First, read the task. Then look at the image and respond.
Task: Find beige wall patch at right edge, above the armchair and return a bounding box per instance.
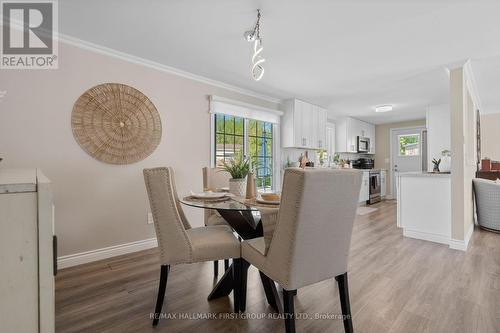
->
[481,113,500,161]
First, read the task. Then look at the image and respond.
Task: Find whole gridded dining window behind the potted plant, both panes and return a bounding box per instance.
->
[214,114,274,191]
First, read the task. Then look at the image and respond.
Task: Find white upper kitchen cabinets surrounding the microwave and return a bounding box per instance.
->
[336,117,375,154]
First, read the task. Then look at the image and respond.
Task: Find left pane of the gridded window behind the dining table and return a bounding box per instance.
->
[215,114,245,167]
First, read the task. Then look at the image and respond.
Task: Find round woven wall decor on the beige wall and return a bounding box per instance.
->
[71,83,161,164]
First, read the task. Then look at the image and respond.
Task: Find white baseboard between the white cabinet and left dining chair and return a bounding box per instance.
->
[57,238,158,269]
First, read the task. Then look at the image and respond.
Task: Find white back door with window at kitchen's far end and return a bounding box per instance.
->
[389,126,427,199]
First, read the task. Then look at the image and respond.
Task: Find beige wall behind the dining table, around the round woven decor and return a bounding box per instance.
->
[0,43,277,255]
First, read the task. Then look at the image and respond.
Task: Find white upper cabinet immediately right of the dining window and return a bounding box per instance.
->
[281,99,327,149]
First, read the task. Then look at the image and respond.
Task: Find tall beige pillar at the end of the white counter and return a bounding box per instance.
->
[450,68,476,241]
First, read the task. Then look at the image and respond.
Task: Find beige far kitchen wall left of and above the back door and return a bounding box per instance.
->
[375,119,425,195]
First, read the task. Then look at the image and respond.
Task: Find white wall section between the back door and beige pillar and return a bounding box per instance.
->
[426,104,451,171]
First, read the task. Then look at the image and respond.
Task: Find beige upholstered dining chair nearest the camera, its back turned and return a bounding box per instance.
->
[240,168,362,332]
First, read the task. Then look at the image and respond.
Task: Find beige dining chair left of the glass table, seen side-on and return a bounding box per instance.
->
[143,168,240,326]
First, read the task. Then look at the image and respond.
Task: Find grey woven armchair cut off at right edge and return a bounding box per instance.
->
[473,178,500,232]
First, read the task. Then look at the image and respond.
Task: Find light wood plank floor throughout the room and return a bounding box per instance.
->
[56,202,500,333]
